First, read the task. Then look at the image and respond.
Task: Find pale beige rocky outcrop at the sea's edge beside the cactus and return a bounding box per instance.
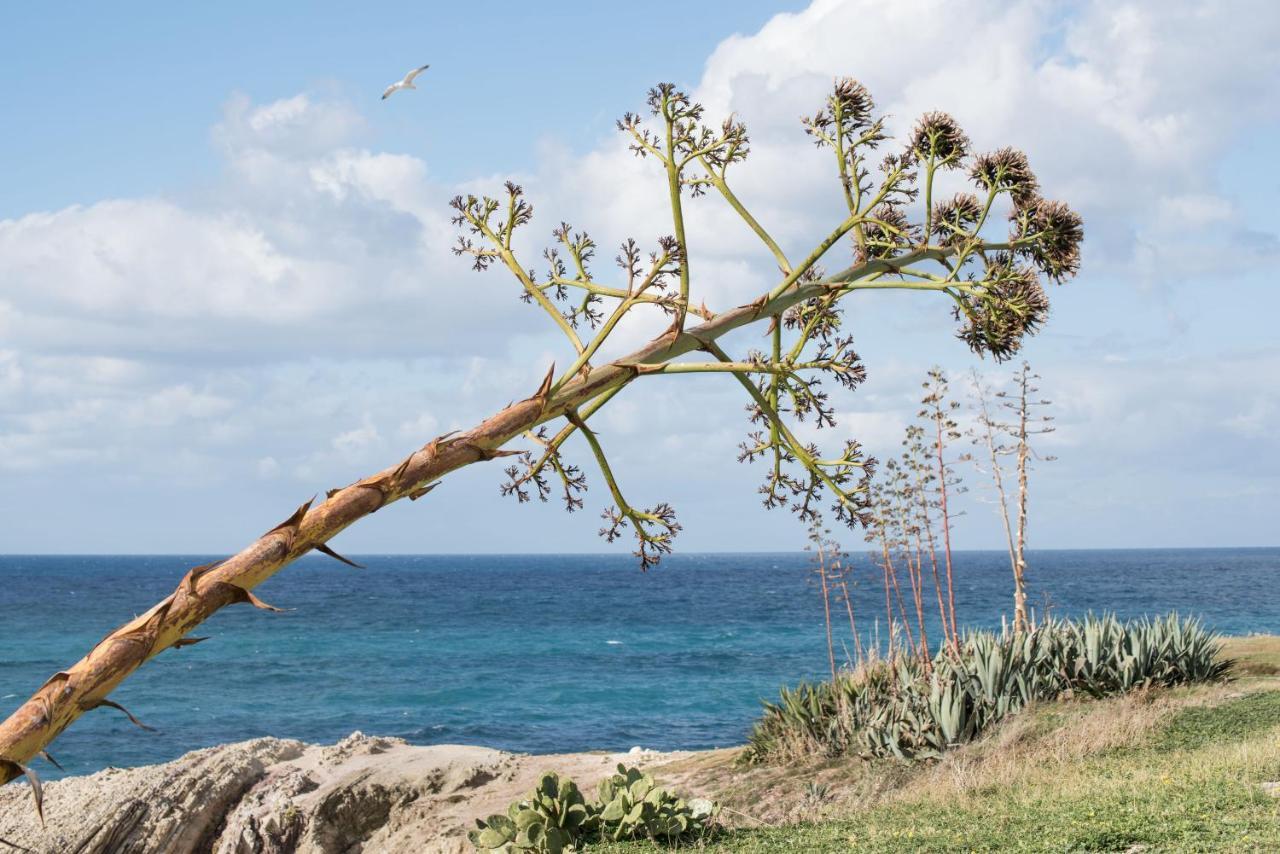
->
[0,732,682,854]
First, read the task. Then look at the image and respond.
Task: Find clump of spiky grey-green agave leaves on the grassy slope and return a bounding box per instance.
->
[742,613,1231,762]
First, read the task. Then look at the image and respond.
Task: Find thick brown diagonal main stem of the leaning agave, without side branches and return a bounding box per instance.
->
[0,247,950,784]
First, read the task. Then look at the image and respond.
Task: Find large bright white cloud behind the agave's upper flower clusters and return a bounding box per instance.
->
[537,0,1280,297]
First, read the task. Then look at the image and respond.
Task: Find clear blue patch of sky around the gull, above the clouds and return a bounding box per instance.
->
[0,0,804,216]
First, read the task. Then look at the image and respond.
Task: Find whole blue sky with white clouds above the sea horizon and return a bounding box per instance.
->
[0,0,1280,553]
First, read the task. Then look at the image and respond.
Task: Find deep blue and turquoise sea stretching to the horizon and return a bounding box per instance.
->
[0,548,1280,776]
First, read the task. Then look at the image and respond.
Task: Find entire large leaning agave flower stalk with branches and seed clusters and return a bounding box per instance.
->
[0,79,1082,814]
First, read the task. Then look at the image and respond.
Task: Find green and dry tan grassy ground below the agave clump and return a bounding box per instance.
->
[591,638,1280,854]
